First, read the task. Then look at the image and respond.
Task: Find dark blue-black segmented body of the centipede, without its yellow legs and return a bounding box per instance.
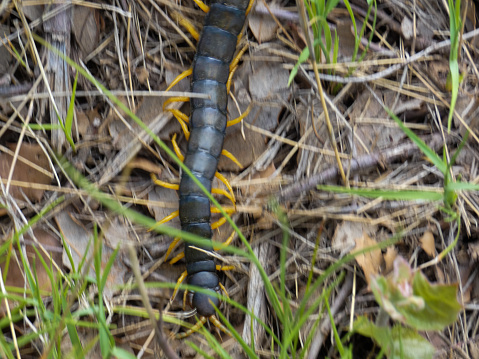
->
[179,0,250,317]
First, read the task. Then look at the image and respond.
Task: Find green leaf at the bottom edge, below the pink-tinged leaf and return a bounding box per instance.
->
[353,317,434,359]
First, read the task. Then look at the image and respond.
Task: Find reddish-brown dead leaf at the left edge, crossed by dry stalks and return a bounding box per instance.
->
[0,143,53,207]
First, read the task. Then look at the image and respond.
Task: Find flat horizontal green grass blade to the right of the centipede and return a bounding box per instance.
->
[317,185,444,201]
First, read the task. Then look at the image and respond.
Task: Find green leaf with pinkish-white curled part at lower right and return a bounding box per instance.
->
[371,257,462,330]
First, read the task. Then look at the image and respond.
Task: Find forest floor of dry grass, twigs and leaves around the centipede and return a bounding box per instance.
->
[0,0,479,358]
